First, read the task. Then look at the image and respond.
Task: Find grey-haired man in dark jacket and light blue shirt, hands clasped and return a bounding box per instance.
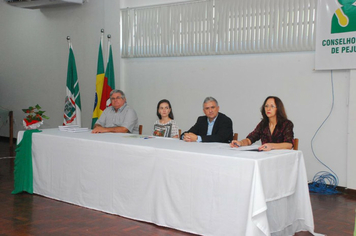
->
[180,97,233,143]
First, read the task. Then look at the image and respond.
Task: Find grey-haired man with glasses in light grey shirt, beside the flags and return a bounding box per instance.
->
[92,89,138,134]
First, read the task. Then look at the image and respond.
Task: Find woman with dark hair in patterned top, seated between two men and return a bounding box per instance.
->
[153,99,178,138]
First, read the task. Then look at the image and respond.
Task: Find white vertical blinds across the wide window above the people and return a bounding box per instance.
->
[121,0,316,57]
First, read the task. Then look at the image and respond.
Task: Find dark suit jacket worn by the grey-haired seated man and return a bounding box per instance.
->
[181,112,233,143]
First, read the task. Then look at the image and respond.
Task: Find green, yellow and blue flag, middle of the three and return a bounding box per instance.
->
[91,34,105,128]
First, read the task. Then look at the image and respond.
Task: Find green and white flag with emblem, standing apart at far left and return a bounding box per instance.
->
[63,43,81,127]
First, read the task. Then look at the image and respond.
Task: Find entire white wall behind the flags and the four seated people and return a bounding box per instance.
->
[0,0,355,186]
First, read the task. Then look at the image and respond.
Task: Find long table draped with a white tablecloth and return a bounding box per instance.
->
[19,129,314,236]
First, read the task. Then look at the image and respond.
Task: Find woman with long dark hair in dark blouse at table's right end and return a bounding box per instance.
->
[230,96,294,151]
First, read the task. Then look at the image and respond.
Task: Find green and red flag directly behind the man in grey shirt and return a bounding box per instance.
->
[100,40,115,111]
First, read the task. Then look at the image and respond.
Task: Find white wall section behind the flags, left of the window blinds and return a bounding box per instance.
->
[0,0,120,135]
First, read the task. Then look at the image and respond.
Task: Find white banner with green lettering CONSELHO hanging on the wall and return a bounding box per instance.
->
[315,0,356,70]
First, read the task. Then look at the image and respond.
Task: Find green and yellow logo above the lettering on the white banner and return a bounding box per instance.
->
[331,0,356,34]
